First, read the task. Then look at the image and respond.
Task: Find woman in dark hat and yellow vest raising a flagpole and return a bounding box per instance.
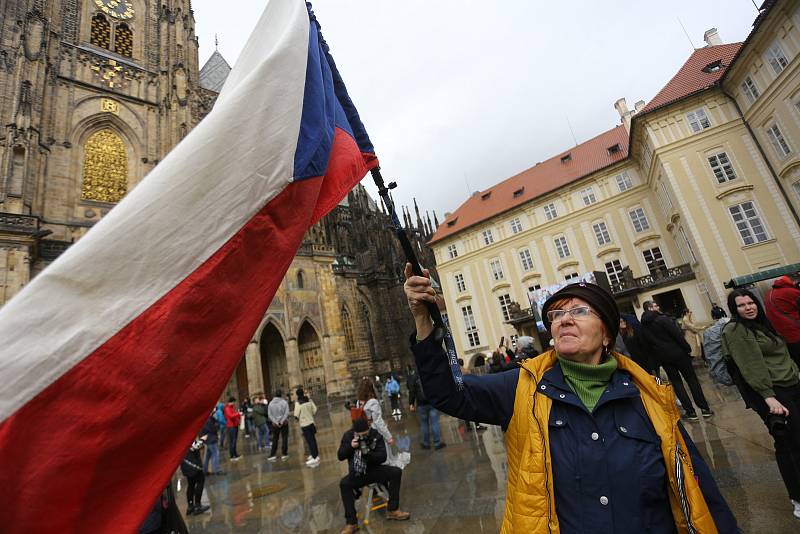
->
[405,265,738,534]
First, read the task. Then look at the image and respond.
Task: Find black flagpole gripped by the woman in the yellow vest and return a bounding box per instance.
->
[370,167,464,390]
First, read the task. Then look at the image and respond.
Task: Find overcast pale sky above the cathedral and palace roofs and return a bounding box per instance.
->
[192,0,760,222]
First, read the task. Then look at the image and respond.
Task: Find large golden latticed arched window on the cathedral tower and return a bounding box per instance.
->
[81,129,128,202]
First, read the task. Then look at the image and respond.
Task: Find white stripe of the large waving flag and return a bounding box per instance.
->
[0,0,308,421]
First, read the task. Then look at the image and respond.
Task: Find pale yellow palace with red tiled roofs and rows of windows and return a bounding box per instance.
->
[429,0,800,363]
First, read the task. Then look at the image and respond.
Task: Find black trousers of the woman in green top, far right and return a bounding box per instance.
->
[756,386,800,502]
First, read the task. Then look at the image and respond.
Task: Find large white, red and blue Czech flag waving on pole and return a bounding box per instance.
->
[0,0,377,534]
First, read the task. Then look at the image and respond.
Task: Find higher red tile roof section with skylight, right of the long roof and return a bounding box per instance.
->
[642,43,742,113]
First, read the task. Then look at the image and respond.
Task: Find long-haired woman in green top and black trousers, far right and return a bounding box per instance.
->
[722,289,800,518]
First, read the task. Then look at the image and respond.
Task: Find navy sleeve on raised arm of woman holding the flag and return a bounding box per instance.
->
[411,335,520,430]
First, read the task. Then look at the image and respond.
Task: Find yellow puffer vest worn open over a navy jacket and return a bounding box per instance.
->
[501,351,717,534]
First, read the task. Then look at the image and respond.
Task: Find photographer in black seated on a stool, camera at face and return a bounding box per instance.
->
[338,418,411,534]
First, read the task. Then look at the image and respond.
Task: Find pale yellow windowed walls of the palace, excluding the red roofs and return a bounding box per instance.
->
[433,2,800,363]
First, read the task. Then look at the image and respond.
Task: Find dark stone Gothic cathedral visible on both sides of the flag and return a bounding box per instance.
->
[0,0,435,397]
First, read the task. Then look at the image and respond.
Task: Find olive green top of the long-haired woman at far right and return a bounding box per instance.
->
[722,322,800,399]
